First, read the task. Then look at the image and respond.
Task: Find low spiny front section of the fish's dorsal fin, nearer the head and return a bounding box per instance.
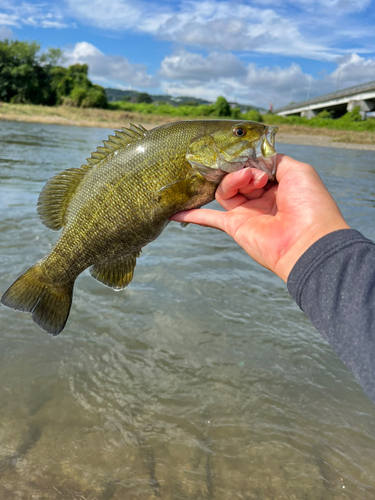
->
[82,123,147,169]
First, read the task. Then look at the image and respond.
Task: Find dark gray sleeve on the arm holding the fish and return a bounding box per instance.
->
[288,229,375,402]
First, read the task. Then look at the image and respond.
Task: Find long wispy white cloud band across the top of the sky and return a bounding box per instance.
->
[64,0,337,60]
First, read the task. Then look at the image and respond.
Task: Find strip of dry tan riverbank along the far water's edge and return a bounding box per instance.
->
[0,103,375,151]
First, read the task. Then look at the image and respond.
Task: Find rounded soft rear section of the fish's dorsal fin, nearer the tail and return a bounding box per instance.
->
[37,168,86,231]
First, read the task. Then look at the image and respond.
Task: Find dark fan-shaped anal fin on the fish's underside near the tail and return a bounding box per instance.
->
[90,252,140,290]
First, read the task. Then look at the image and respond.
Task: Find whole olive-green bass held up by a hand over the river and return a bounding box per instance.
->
[1,120,277,336]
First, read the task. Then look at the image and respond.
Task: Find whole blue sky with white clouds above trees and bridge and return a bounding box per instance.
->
[0,0,375,109]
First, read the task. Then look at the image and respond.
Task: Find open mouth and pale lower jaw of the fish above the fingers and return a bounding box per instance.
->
[218,127,278,181]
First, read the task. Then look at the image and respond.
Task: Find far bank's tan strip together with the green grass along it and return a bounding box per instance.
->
[0,103,375,145]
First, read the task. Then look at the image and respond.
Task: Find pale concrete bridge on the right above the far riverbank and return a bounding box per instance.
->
[274,81,375,119]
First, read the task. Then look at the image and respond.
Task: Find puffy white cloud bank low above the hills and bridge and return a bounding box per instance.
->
[162,48,375,108]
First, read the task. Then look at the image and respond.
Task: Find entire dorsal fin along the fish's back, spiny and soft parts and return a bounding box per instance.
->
[37,123,147,231]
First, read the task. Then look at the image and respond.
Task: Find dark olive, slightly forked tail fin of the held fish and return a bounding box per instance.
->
[1,264,74,335]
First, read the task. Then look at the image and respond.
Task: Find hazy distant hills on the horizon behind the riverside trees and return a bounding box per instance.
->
[105,88,266,113]
